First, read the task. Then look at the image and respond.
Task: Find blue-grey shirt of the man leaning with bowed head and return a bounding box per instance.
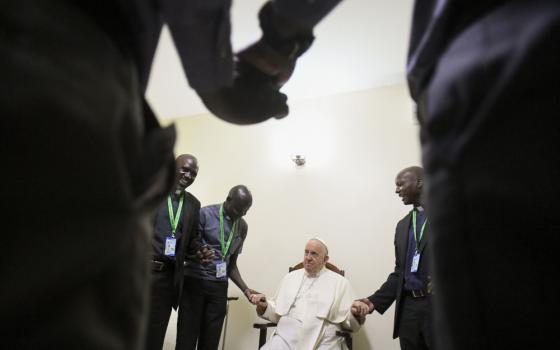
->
[185,204,246,281]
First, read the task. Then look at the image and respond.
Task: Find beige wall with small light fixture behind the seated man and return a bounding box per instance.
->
[160,84,420,350]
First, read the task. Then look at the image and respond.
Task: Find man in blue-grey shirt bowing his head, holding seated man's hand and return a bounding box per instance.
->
[177,185,256,350]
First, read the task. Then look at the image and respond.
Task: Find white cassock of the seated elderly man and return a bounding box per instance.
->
[260,268,360,350]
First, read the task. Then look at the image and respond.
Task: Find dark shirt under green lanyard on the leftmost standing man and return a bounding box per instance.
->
[152,197,185,260]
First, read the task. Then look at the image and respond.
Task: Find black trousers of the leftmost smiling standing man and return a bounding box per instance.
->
[144,268,180,350]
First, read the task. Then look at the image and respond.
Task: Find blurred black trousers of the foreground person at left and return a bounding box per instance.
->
[0,0,173,350]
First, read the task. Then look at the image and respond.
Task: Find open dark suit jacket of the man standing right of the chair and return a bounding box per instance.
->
[368,211,431,338]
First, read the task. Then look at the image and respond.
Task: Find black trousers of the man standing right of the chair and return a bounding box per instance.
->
[399,296,434,350]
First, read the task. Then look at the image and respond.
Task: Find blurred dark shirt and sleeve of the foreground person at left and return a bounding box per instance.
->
[75,0,233,94]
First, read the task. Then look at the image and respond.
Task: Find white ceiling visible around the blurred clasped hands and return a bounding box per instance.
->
[146,0,413,119]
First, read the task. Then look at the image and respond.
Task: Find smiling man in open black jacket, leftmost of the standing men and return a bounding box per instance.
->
[145,154,200,350]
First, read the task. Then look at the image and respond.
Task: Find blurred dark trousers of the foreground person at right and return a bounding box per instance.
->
[422,1,560,350]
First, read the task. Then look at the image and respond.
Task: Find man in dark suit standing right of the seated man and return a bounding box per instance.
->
[361,166,434,350]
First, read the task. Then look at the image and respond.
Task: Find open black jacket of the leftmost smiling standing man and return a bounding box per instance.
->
[173,192,202,307]
